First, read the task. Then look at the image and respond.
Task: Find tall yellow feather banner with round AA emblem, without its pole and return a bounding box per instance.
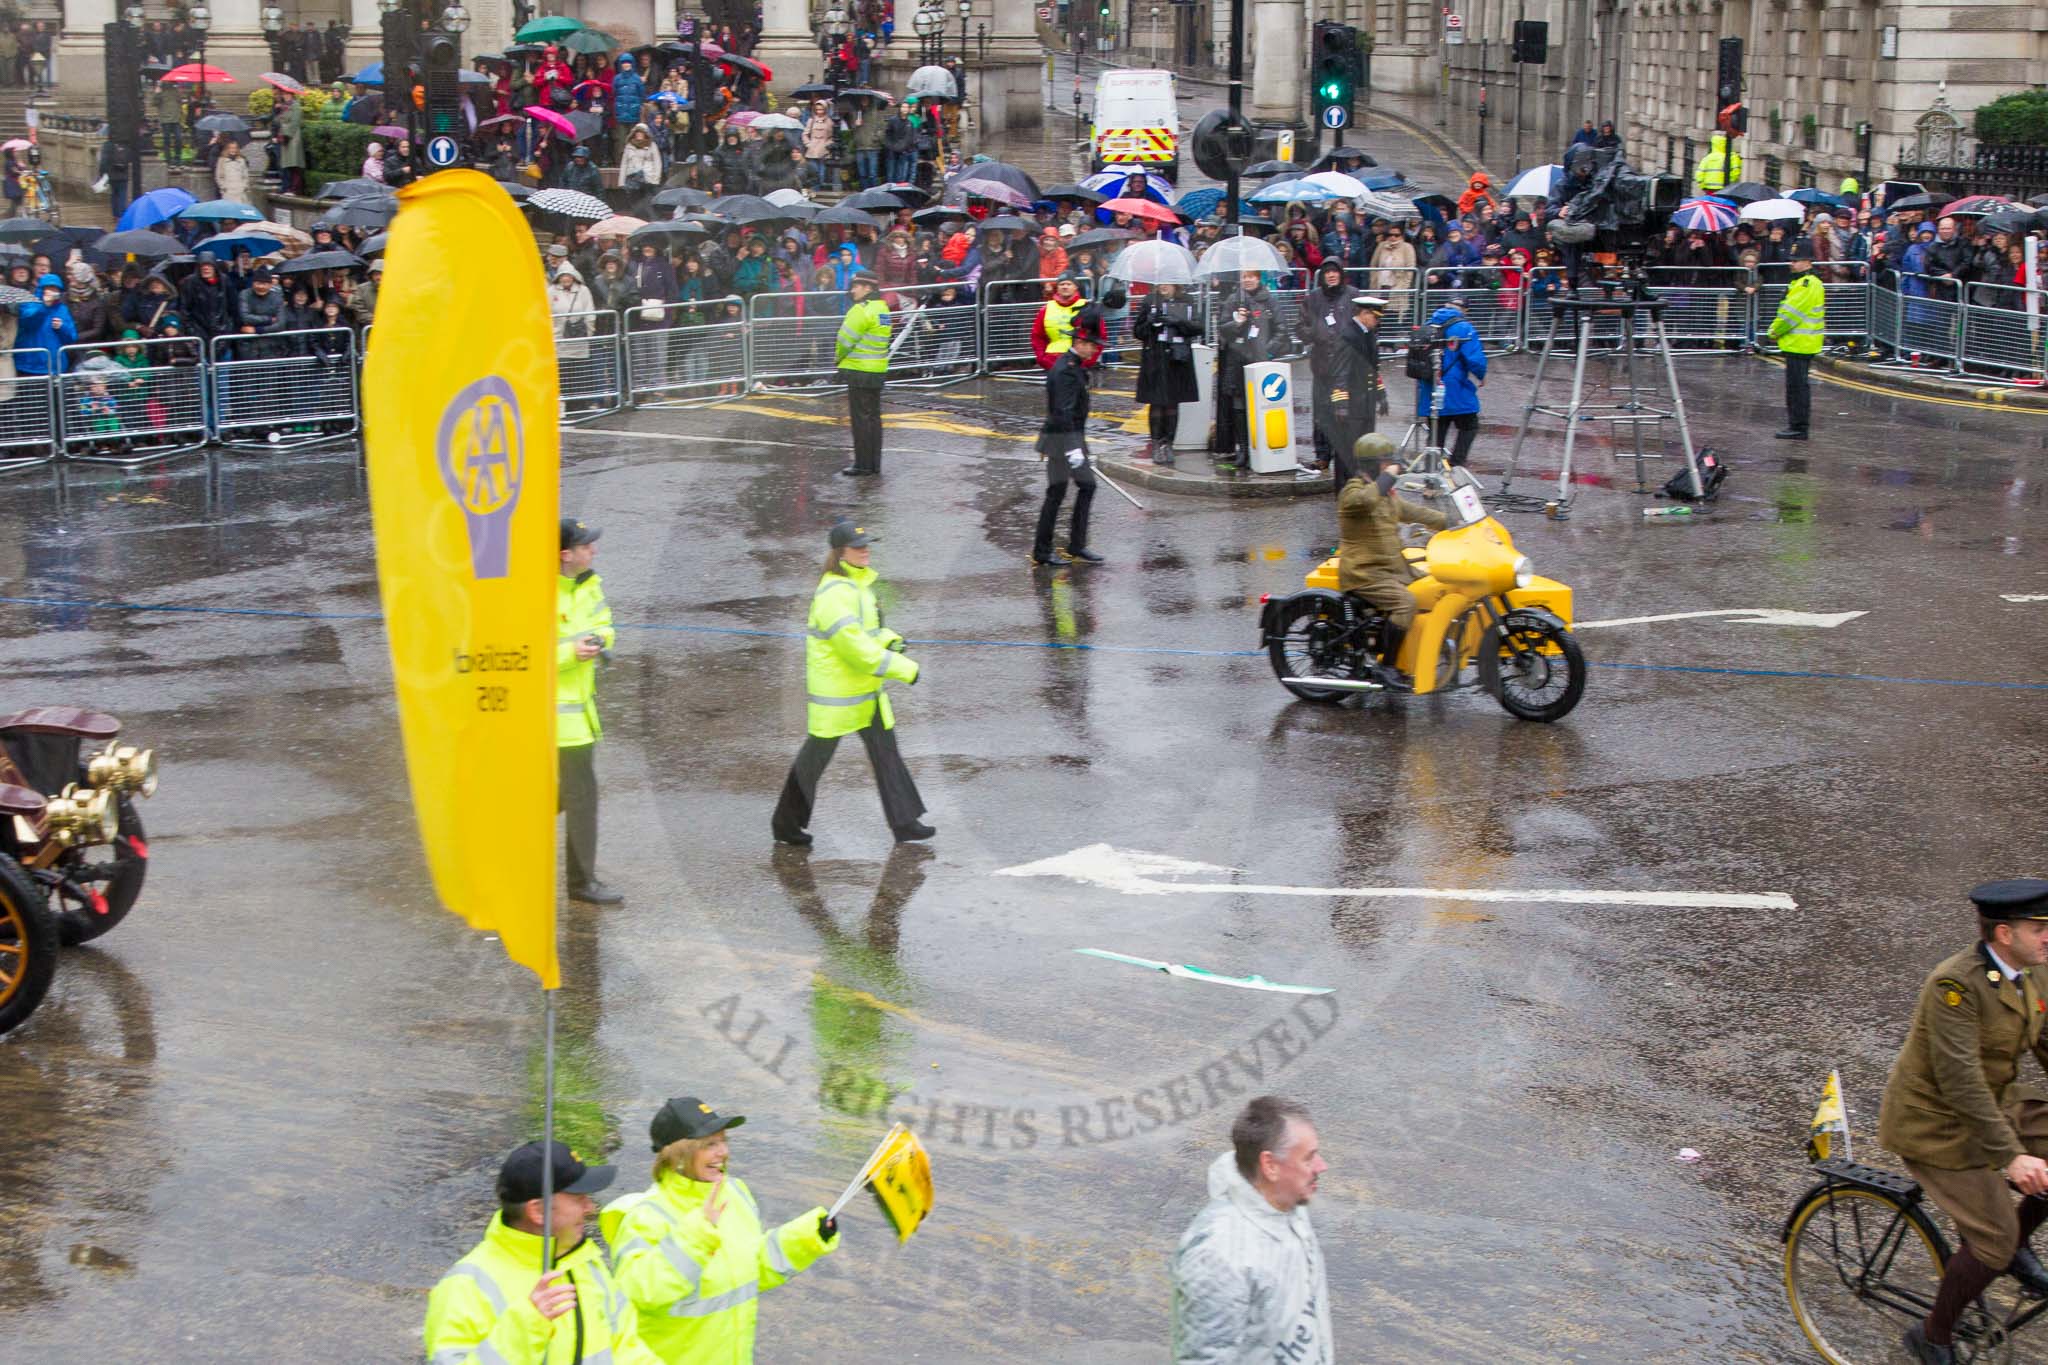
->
[362,170,561,988]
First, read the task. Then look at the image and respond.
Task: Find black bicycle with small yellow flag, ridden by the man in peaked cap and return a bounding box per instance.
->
[1780,1156,2048,1365]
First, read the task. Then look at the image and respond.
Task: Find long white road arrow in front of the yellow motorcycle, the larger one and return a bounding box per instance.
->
[995,843,1798,911]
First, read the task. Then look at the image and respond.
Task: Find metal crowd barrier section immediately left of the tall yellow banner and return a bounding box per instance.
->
[209,327,362,446]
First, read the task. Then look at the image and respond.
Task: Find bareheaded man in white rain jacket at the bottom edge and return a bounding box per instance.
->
[1174,1095,1337,1365]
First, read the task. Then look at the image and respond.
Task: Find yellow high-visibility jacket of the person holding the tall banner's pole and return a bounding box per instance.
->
[426,1214,662,1365]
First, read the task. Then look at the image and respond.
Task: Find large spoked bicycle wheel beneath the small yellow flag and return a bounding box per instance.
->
[1784,1185,1948,1365]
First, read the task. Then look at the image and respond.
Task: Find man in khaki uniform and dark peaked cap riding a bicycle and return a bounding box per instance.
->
[1878,878,2048,1365]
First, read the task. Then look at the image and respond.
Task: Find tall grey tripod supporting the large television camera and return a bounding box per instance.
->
[1501,276,1706,510]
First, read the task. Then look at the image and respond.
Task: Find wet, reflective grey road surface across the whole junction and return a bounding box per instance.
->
[0,333,2048,1363]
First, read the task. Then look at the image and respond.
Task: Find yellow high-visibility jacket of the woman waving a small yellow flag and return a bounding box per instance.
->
[598,1171,840,1365]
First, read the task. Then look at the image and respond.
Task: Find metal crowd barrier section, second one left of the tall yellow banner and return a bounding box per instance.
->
[55,336,213,465]
